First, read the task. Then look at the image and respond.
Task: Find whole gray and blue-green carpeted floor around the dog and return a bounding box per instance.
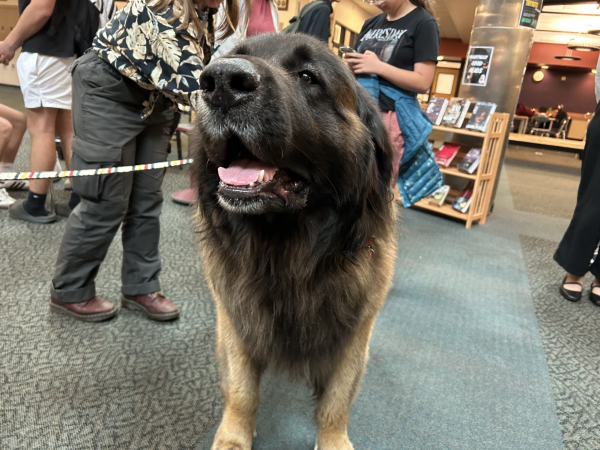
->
[0,83,600,450]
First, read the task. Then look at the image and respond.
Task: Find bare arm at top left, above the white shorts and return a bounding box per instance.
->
[0,0,56,65]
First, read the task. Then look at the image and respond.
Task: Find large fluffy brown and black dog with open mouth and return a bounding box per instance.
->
[193,35,396,450]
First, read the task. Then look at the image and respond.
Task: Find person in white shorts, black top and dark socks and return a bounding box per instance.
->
[0,0,75,223]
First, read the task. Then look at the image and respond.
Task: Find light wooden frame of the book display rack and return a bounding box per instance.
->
[414,113,509,228]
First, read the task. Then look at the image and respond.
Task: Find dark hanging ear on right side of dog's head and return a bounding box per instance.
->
[356,86,393,200]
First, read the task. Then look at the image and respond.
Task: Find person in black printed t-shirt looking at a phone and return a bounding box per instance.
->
[344,0,440,187]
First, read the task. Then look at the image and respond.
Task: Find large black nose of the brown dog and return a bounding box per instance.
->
[200,58,260,113]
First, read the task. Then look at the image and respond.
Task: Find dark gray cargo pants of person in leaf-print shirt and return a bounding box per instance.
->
[51,51,175,303]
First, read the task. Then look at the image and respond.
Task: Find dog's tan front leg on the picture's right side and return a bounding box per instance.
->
[316,318,375,450]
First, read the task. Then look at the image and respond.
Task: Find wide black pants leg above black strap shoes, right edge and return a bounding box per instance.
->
[554,104,600,278]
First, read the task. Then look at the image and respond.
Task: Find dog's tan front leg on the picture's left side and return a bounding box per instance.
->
[211,306,262,450]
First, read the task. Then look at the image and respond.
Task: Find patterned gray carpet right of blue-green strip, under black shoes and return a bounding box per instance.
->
[521,236,600,449]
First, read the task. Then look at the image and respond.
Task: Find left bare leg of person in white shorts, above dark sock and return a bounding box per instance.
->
[27,108,58,194]
